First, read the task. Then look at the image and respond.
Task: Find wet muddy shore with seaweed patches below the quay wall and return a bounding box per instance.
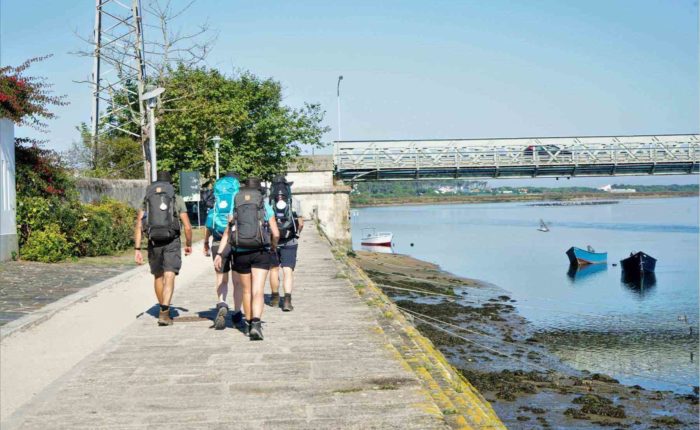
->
[355,251,698,429]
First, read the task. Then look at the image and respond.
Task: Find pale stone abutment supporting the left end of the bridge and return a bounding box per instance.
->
[287,155,351,244]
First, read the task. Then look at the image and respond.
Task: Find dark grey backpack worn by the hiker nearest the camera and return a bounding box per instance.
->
[231,187,270,249]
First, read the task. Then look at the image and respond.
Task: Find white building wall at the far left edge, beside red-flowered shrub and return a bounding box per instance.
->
[0,118,17,261]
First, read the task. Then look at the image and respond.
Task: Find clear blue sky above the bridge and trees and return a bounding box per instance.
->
[0,0,700,185]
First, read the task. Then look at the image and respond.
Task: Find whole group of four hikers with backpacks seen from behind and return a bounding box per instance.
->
[134,171,304,340]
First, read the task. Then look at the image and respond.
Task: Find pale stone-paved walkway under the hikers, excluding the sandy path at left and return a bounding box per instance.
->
[2,228,446,430]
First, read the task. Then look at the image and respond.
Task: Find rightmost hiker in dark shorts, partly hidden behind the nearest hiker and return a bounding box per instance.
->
[270,175,304,312]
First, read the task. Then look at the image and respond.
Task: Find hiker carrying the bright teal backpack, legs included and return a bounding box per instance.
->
[204,172,243,330]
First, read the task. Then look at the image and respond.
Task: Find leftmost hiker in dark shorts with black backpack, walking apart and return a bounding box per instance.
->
[134,171,192,326]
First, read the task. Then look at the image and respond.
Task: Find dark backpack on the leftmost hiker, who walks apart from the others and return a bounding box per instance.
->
[144,182,180,243]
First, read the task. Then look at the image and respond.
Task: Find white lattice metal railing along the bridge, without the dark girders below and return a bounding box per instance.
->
[335,135,700,171]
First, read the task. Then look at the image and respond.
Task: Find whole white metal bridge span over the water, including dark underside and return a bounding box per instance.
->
[334,134,700,181]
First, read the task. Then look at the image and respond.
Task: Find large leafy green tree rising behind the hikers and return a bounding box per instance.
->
[110,64,328,178]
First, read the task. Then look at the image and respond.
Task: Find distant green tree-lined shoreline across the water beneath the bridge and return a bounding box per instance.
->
[350,191,698,208]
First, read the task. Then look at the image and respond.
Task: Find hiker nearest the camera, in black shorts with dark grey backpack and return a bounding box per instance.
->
[214,178,279,340]
